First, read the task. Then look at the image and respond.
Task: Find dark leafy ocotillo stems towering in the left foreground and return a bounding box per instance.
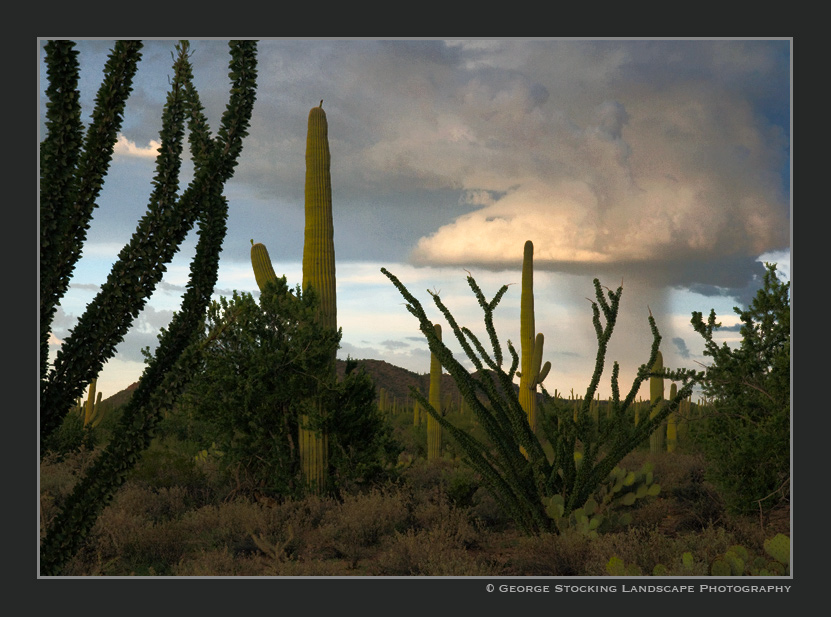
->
[40,41,257,575]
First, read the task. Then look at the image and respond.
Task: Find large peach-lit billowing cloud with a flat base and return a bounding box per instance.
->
[412,82,787,282]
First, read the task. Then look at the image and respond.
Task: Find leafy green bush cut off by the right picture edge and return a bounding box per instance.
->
[691,264,791,513]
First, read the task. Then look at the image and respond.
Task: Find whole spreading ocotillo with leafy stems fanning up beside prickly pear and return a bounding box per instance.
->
[382,268,700,534]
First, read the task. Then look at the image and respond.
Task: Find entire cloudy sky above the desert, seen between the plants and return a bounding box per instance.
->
[38,39,792,404]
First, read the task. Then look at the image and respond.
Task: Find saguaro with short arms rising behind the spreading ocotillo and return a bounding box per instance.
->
[519,240,551,432]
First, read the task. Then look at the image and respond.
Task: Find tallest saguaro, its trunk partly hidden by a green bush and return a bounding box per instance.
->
[300,101,338,491]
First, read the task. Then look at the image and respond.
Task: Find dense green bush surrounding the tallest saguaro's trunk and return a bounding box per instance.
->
[177,277,396,496]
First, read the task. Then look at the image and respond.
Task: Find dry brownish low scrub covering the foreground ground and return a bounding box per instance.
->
[40,438,790,577]
